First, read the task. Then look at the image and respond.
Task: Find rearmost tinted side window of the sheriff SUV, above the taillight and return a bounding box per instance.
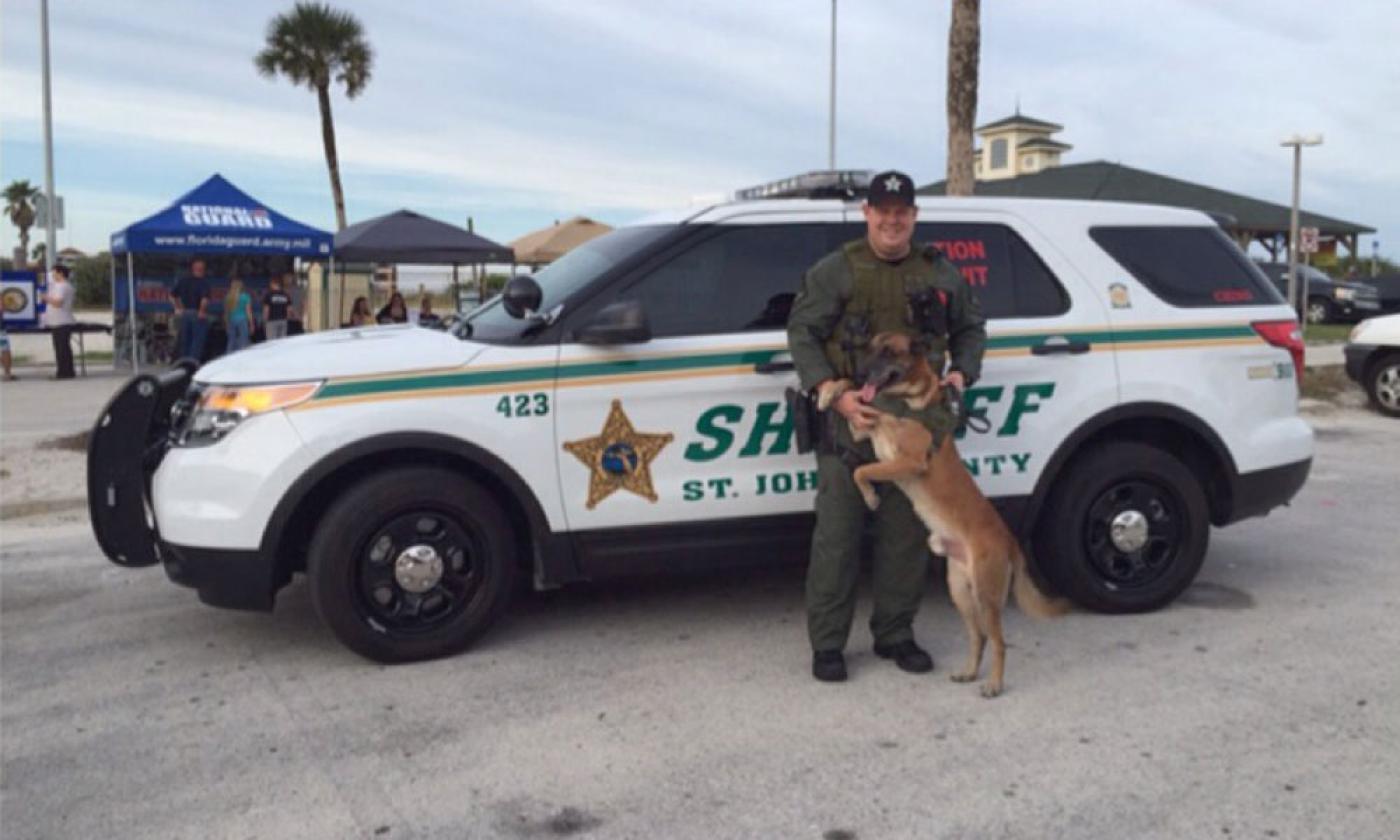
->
[1089,227,1282,307]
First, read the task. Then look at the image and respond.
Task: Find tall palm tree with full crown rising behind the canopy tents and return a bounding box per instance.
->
[253,3,374,230]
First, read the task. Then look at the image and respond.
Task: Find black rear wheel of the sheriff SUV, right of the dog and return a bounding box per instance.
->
[1036,441,1210,613]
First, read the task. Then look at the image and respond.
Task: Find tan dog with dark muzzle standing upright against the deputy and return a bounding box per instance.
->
[818,333,1068,697]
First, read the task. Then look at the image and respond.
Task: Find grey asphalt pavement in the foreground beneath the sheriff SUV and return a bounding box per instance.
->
[0,383,1400,840]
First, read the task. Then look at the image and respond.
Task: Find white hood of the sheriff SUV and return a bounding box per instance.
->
[195,325,486,385]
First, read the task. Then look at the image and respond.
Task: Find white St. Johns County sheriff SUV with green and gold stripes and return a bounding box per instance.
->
[88,178,1313,661]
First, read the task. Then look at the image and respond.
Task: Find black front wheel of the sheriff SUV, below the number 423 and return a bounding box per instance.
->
[307,468,515,662]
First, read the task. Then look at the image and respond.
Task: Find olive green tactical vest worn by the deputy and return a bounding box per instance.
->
[825,239,948,378]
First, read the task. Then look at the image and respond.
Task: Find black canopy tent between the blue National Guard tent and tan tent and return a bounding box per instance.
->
[335,210,515,320]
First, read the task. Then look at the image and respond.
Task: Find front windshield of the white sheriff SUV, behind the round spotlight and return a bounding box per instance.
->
[454,225,675,342]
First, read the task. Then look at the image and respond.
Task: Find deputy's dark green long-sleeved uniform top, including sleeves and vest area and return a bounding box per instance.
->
[788,239,987,389]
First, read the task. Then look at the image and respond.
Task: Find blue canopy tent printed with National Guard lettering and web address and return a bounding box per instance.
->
[112,172,333,370]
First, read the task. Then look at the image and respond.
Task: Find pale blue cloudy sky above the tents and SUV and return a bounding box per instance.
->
[0,0,1400,258]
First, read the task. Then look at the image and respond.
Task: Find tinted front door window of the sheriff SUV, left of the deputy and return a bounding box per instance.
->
[619,224,832,337]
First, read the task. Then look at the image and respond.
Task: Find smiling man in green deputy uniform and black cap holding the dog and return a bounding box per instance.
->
[788,171,987,682]
